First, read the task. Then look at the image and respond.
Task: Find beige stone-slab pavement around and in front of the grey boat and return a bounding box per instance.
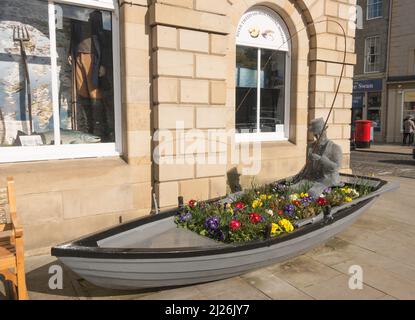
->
[0,152,415,300]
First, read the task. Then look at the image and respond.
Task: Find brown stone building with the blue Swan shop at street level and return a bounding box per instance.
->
[352,0,390,142]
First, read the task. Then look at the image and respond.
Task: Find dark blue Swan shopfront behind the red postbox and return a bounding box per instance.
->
[352,79,383,142]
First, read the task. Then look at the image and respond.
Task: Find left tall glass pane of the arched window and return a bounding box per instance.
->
[236,46,258,132]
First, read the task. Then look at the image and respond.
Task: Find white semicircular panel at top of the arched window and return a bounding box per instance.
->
[236,7,289,51]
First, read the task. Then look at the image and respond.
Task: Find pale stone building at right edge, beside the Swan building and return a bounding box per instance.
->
[386,0,415,143]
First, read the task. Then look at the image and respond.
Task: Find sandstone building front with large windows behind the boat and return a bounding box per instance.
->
[0,0,358,250]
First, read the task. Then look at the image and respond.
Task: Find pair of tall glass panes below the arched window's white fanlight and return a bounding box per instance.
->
[236,46,286,133]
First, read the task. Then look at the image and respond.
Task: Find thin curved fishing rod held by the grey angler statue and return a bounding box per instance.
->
[236,19,347,153]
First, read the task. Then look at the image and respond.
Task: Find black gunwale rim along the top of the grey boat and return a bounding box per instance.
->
[51,174,387,259]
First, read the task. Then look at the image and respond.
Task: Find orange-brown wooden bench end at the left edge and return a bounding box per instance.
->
[0,178,28,300]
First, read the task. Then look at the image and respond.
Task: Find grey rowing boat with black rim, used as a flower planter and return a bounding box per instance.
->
[52,175,399,289]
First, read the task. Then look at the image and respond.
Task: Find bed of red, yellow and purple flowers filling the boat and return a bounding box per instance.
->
[175,183,372,243]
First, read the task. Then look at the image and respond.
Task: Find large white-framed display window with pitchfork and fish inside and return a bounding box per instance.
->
[0,0,119,162]
